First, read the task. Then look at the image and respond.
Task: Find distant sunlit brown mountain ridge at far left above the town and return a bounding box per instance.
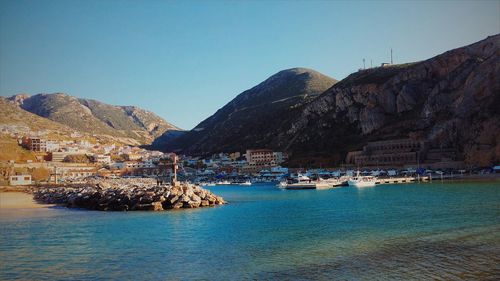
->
[8,93,178,144]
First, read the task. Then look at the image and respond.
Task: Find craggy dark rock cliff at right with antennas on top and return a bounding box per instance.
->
[277,35,500,166]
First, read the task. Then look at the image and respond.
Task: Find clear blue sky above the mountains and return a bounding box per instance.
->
[0,0,500,129]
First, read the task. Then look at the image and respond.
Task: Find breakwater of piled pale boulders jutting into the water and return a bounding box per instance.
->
[34,181,226,211]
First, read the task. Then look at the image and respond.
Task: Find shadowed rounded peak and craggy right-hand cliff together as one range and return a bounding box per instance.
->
[153,35,500,165]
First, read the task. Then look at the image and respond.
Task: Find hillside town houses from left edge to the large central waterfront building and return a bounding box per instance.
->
[1,126,288,185]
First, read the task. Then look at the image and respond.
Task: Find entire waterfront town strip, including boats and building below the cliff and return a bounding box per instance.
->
[0,126,500,189]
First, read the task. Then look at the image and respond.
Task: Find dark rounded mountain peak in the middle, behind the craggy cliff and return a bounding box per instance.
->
[153,68,336,154]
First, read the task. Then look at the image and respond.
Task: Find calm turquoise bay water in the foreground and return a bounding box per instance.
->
[0,182,500,280]
